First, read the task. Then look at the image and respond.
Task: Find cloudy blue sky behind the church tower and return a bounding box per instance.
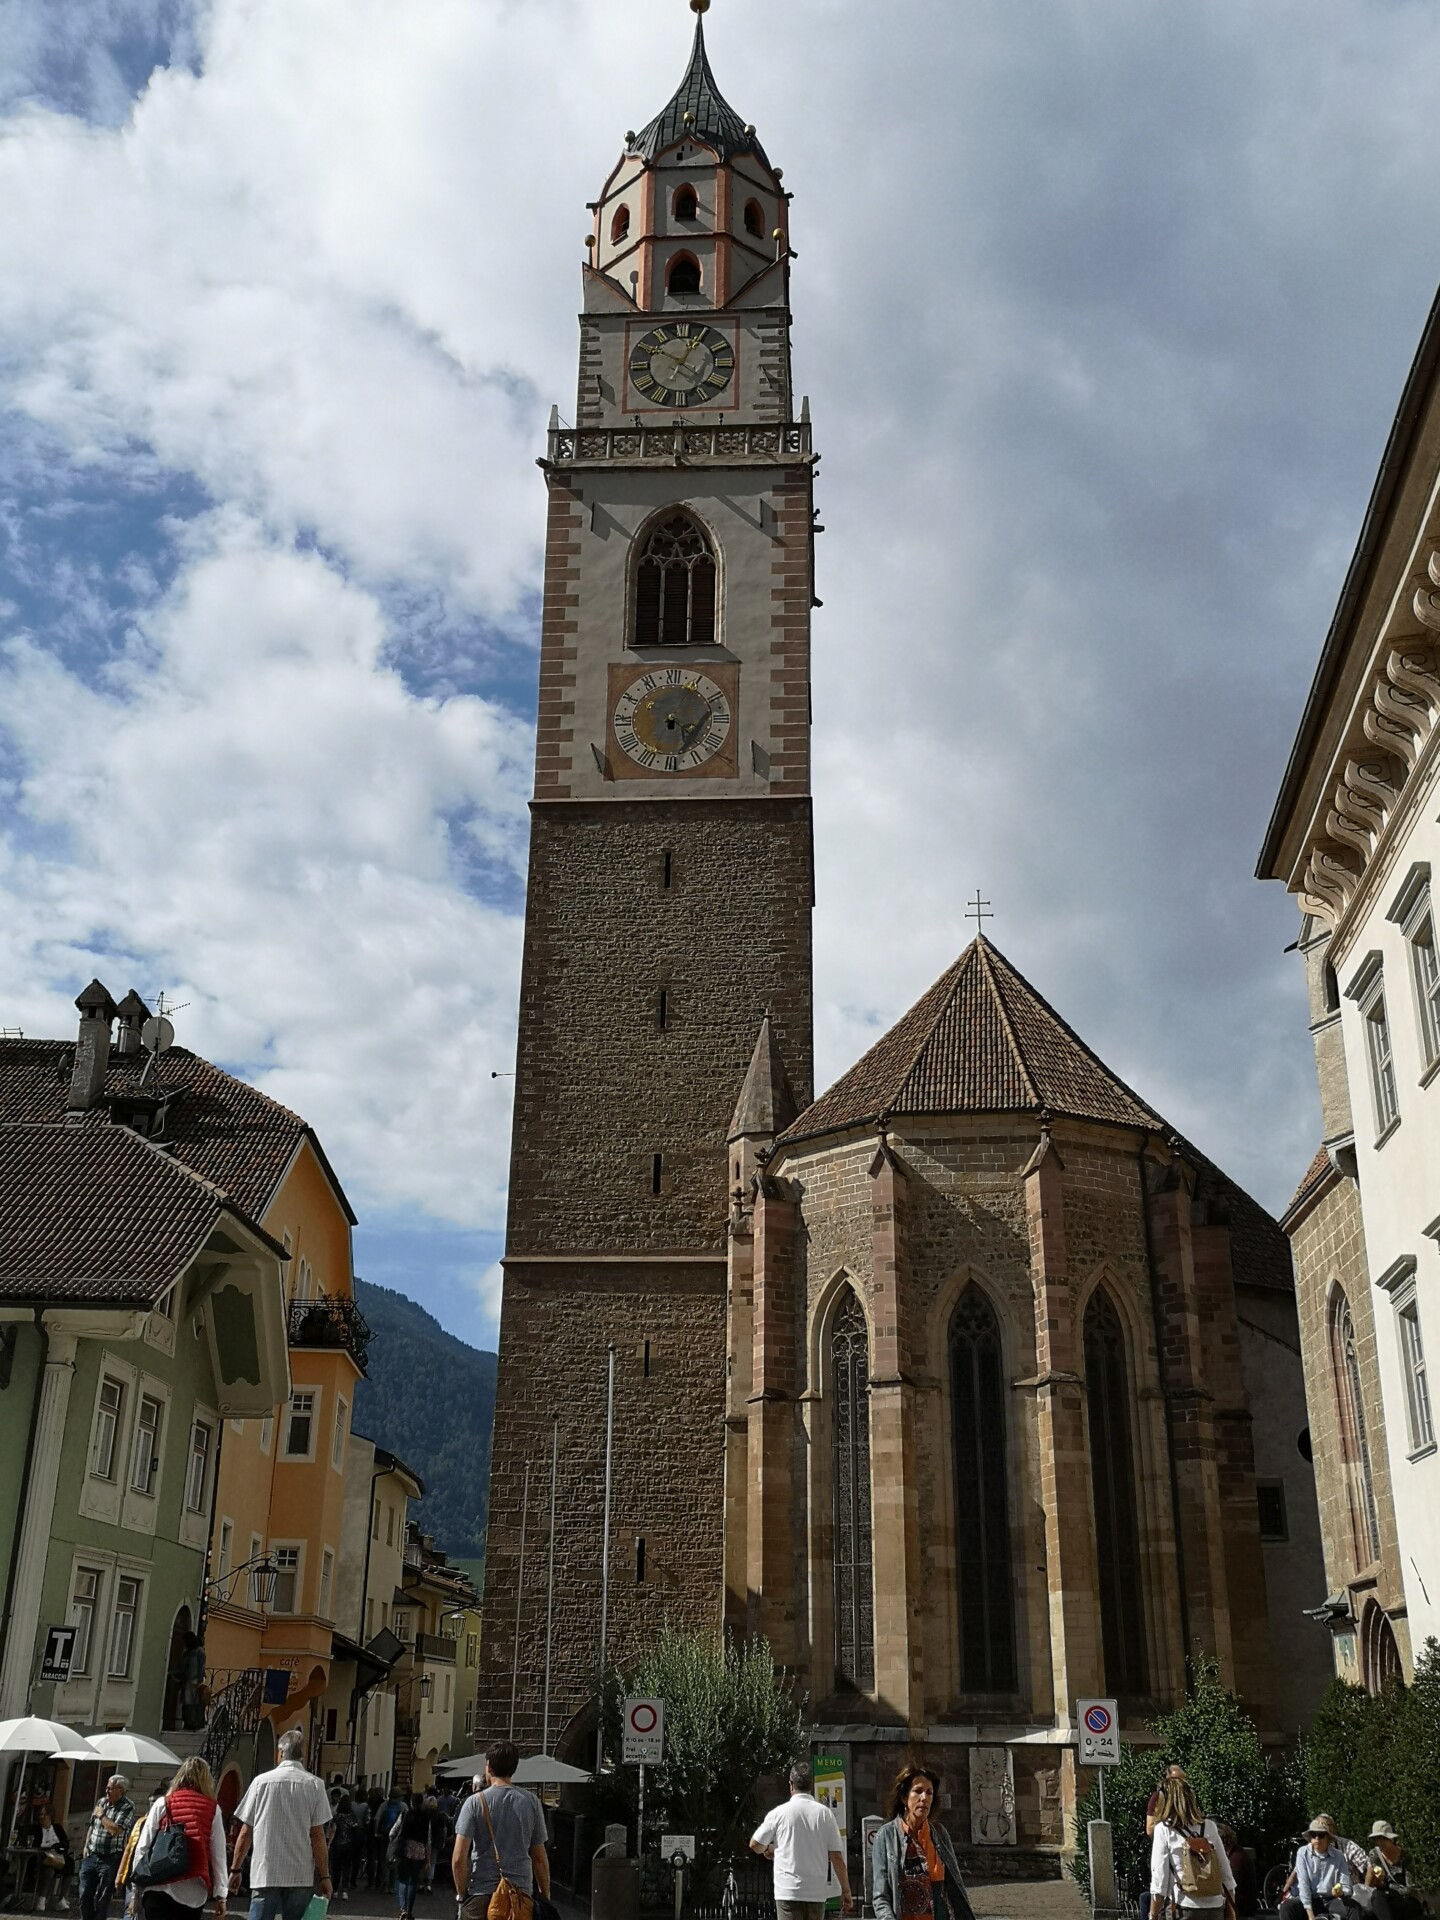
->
[0,0,1440,1344]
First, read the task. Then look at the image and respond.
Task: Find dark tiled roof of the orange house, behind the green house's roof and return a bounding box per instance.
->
[0,1039,353,1219]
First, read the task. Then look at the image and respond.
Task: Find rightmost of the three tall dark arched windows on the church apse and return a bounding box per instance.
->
[1085,1286,1150,1695]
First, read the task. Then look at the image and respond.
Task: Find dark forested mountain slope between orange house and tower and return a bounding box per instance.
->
[353,1281,497,1559]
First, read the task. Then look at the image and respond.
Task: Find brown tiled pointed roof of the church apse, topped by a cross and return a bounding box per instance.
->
[783,937,1165,1140]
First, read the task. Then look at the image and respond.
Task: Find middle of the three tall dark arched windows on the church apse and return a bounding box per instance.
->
[950,1286,1016,1693]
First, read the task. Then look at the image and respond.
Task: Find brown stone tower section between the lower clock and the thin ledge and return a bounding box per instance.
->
[501,799,812,1251]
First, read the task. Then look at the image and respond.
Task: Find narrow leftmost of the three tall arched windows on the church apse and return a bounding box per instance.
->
[829,1288,876,1693]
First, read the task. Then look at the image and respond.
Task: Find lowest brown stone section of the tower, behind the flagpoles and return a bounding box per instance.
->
[476,1265,726,1764]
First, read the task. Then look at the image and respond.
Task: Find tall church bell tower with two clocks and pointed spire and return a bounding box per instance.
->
[480,0,816,1753]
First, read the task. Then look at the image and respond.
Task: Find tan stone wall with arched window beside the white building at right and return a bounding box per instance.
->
[1290,1179,1411,1678]
